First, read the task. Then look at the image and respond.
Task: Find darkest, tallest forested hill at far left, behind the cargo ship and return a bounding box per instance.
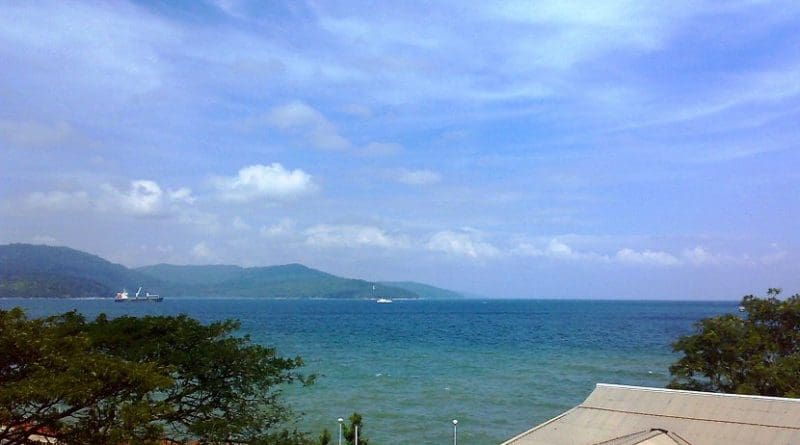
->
[0,244,160,298]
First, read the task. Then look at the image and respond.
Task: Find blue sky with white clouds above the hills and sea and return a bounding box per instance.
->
[0,0,800,299]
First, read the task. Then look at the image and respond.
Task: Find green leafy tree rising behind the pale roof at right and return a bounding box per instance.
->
[669,288,800,397]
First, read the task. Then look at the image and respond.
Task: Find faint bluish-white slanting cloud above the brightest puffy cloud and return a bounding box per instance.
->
[267,101,351,150]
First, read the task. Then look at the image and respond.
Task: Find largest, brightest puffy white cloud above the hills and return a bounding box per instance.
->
[211,163,317,202]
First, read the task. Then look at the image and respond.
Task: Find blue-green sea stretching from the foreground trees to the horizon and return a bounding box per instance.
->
[0,298,738,445]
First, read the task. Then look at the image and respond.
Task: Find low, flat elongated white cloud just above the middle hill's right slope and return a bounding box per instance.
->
[305,224,409,249]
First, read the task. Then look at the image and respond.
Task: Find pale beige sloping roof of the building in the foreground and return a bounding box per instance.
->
[502,383,800,445]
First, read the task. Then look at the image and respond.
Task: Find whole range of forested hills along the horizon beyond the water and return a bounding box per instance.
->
[0,244,461,298]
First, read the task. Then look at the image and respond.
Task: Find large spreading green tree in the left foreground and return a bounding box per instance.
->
[0,309,309,445]
